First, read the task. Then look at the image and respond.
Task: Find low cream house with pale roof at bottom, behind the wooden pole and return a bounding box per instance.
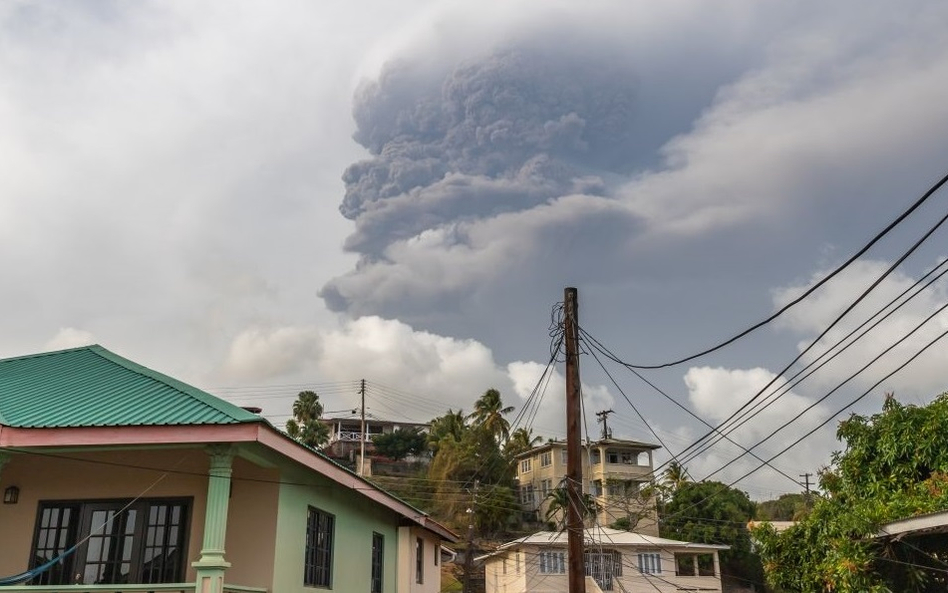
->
[477,527,728,593]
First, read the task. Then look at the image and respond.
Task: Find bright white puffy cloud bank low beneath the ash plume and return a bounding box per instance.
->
[221,316,631,438]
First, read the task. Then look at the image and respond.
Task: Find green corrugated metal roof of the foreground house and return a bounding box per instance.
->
[0,345,265,428]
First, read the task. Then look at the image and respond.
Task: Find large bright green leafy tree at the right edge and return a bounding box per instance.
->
[754,394,948,593]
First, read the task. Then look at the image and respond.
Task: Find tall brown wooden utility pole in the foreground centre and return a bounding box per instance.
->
[563,287,586,593]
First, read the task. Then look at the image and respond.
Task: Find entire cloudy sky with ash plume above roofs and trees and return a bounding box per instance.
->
[0,0,948,499]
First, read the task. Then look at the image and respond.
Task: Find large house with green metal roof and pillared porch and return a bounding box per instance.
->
[0,346,457,593]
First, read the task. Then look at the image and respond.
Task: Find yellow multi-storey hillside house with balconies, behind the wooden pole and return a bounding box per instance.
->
[516,438,661,536]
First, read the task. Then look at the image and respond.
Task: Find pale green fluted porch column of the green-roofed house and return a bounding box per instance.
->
[191,445,234,593]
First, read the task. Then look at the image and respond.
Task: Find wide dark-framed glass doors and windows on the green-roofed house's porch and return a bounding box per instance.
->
[32,499,190,585]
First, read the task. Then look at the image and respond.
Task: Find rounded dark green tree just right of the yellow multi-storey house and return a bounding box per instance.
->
[661,481,763,584]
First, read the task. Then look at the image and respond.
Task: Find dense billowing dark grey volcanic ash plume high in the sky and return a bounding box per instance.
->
[322,43,636,315]
